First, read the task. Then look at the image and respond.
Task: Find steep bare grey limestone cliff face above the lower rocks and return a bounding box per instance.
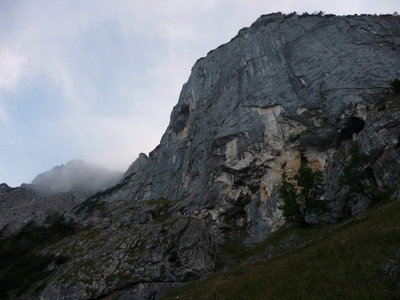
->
[94,14,400,237]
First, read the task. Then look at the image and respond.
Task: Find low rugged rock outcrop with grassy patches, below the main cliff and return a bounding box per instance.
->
[42,199,219,299]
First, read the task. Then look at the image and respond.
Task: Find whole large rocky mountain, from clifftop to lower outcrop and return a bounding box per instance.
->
[0,13,400,299]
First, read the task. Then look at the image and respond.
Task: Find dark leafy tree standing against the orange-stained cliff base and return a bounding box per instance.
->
[279,160,327,226]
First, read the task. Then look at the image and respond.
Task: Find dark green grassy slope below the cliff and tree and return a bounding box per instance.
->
[165,201,400,299]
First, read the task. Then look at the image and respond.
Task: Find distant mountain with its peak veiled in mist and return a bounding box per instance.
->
[0,160,122,233]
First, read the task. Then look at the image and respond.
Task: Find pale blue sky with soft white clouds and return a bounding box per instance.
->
[0,0,400,186]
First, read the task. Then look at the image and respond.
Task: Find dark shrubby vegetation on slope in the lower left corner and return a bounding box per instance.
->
[0,214,78,299]
